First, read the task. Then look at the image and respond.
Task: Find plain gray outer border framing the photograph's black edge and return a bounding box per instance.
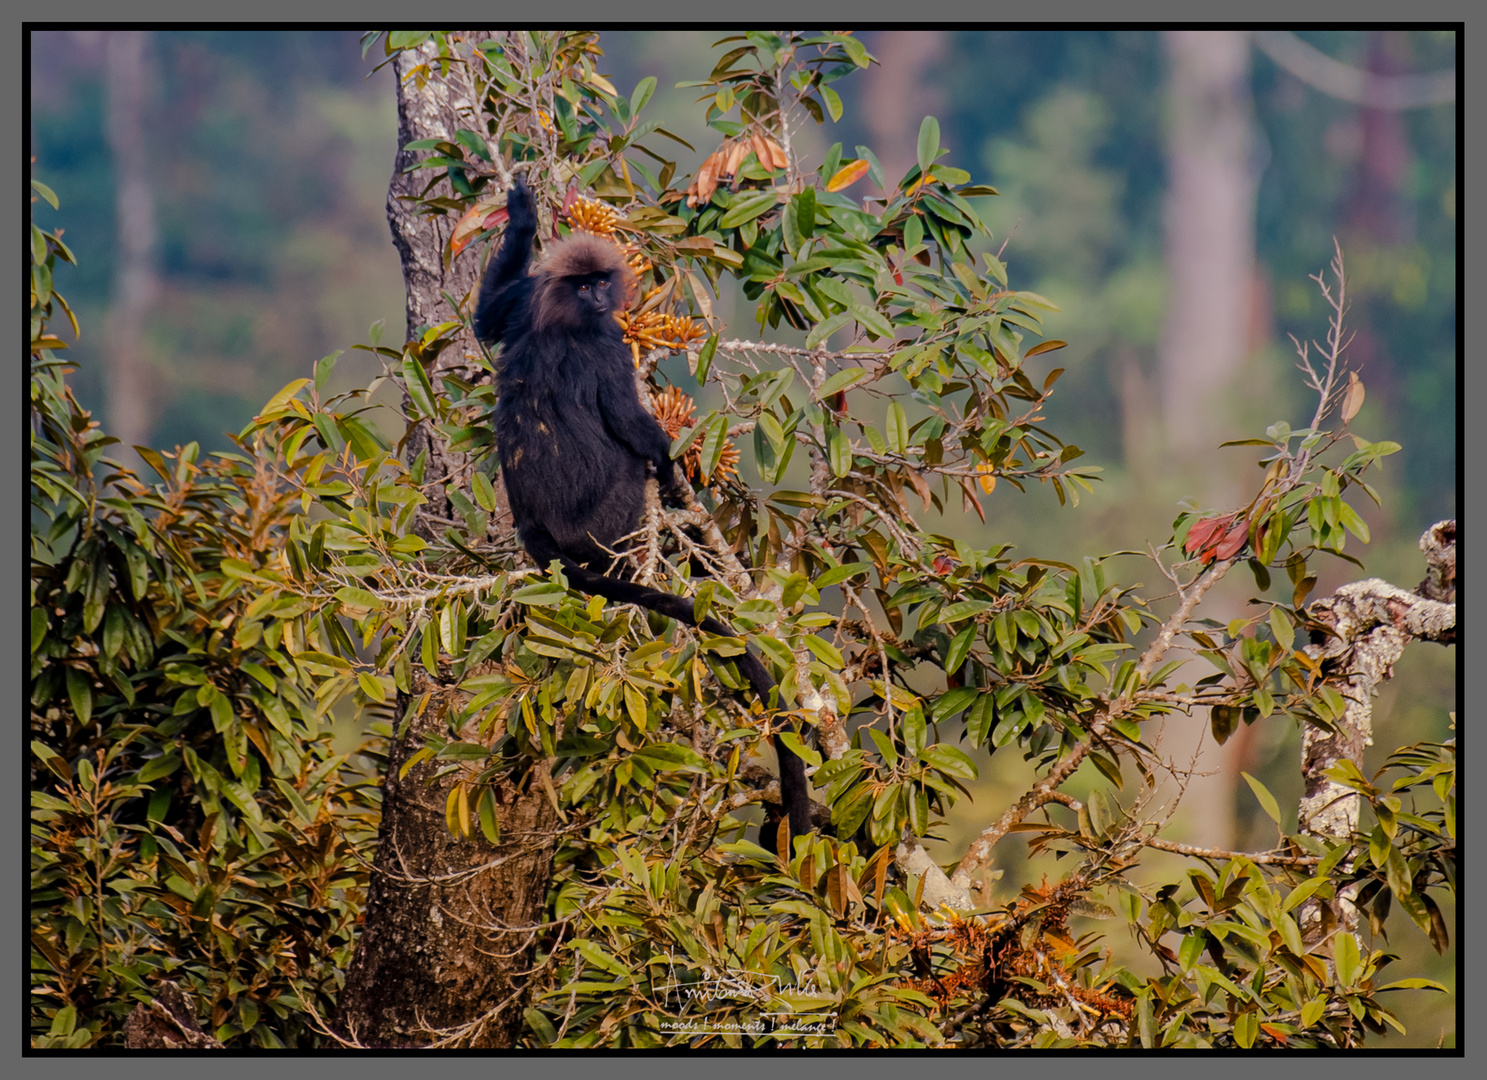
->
[11,0,1487,1080]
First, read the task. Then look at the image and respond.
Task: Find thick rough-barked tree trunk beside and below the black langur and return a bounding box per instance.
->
[335,38,556,1047]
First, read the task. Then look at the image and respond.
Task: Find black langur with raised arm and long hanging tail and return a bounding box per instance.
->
[474,179,810,836]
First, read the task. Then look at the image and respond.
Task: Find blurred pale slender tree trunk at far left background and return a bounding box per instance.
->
[100,30,161,463]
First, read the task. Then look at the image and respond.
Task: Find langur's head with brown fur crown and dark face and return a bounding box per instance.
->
[532,234,635,333]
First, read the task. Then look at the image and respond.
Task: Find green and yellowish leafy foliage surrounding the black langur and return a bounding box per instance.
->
[31,31,1456,1047]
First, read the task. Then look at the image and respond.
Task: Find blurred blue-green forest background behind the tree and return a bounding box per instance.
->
[30,30,1459,1041]
